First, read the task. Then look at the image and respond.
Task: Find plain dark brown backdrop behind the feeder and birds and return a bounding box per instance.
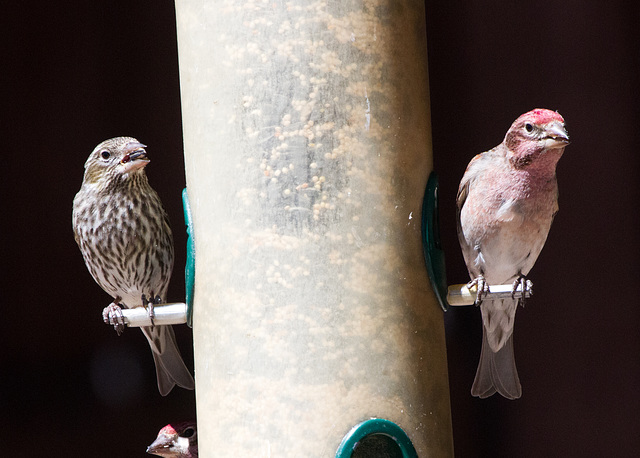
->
[0,0,640,457]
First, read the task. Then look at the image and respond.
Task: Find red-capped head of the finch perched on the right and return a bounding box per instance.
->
[504,108,569,169]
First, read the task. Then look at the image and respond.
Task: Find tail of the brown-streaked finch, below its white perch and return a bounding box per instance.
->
[140,326,195,396]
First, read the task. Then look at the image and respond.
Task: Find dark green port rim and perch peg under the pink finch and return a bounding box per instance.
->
[422,172,532,312]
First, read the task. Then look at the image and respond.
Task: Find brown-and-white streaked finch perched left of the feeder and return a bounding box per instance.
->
[73,137,194,396]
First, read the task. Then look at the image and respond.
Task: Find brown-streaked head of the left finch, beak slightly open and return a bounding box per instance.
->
[84,137,149,185]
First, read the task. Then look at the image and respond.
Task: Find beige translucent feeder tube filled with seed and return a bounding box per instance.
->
[176,0,453,458]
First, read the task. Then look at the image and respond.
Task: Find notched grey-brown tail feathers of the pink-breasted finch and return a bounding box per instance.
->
[471,327,522,399]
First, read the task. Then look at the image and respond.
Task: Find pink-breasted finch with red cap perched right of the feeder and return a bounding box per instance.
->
[457,109,569,399]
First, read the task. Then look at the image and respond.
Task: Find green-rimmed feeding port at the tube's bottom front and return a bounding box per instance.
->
[336,418,418,458]
